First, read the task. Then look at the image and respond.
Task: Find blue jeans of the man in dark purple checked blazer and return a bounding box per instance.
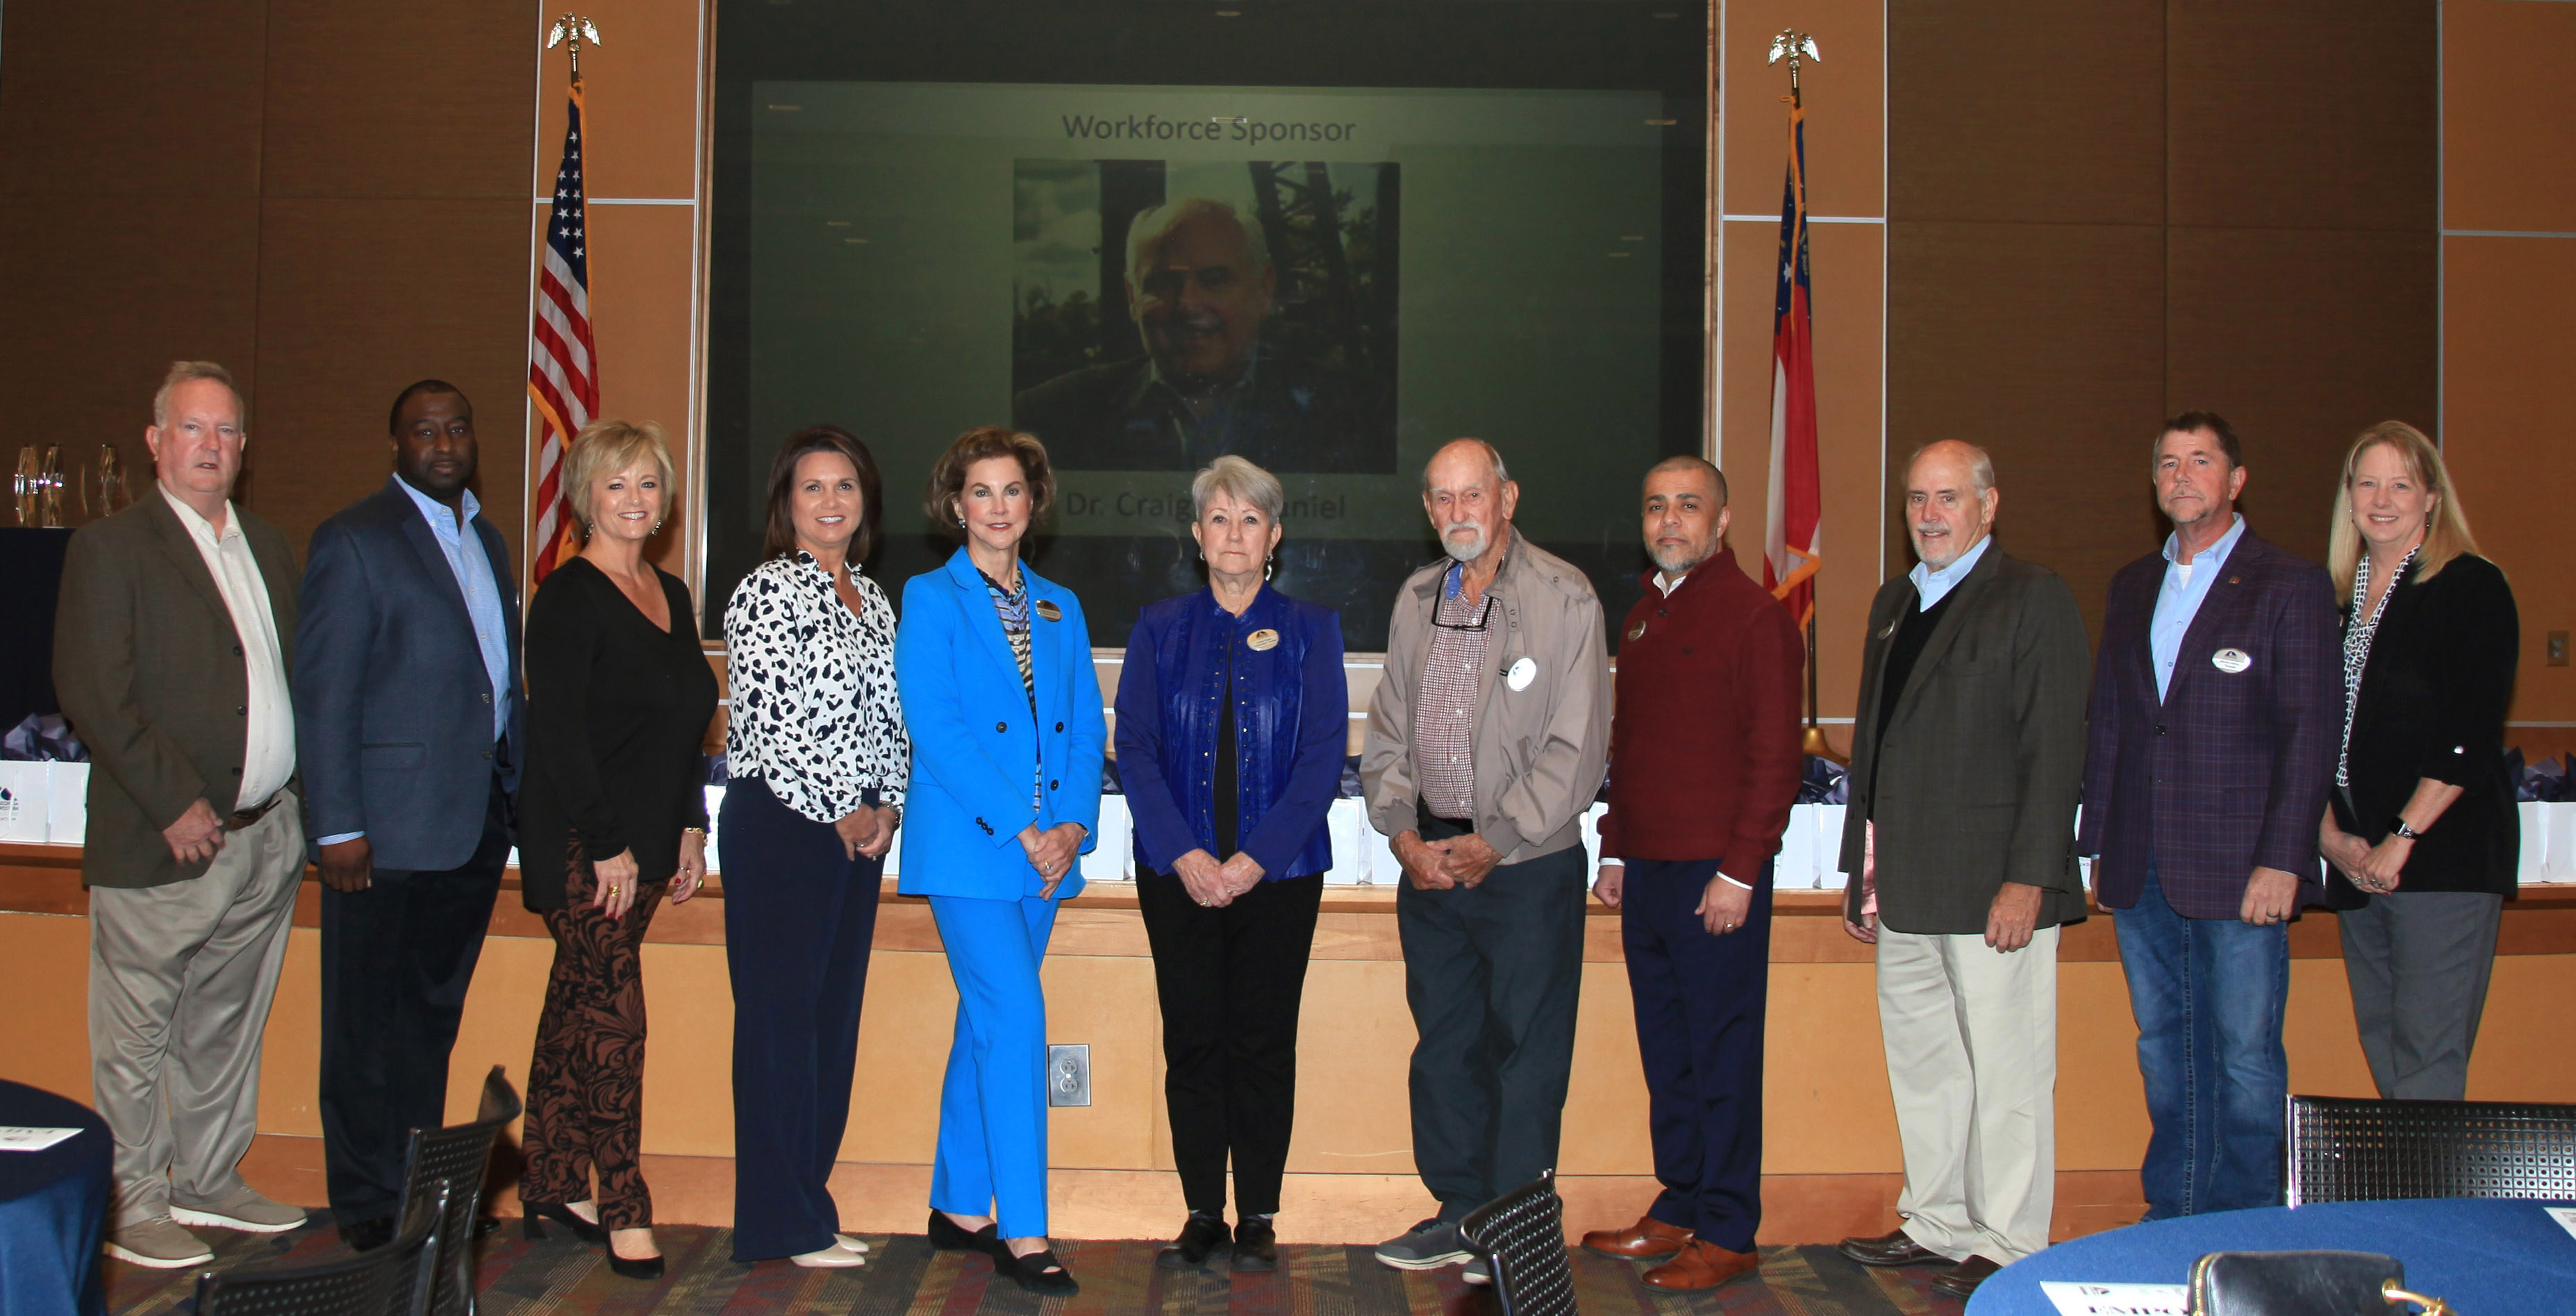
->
[2112,860,2290,1221]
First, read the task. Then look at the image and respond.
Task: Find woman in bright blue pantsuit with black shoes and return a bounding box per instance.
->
[894,425,1105,1293]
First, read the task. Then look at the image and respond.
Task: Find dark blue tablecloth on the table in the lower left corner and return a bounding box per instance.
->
[0,1079,116,1316]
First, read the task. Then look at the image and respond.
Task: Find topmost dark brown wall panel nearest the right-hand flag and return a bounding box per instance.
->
[1888,0,2164,225]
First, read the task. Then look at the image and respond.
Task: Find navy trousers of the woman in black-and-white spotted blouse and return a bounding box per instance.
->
[716,778,886,1262]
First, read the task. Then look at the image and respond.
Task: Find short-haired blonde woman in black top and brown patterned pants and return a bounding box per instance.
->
[518,419,716,1280]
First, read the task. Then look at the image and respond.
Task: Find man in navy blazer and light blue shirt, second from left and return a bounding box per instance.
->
[297,378,520,1249]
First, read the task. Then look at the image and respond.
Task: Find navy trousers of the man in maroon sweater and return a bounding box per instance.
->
[1618,860,1772,1251]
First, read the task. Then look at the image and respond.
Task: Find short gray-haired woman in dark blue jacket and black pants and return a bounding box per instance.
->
[1118,456,1350,1269]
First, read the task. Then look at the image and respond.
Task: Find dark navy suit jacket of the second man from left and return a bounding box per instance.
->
[294,476,526,873]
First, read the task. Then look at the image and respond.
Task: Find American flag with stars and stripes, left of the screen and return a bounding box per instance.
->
[528,77,600,582]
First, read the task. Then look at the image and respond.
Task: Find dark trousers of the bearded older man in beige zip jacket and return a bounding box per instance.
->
[1396,829,1584,1221]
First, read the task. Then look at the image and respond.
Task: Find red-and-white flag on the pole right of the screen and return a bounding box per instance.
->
[1762,103,1824,628]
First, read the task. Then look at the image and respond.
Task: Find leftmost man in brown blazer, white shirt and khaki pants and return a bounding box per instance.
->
[54,360,304,1269]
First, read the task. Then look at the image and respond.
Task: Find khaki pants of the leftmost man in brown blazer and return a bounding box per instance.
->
[90,796,304,1228]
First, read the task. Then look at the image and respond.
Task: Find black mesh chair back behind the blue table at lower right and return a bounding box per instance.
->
[2282,1097,2576,1206]
